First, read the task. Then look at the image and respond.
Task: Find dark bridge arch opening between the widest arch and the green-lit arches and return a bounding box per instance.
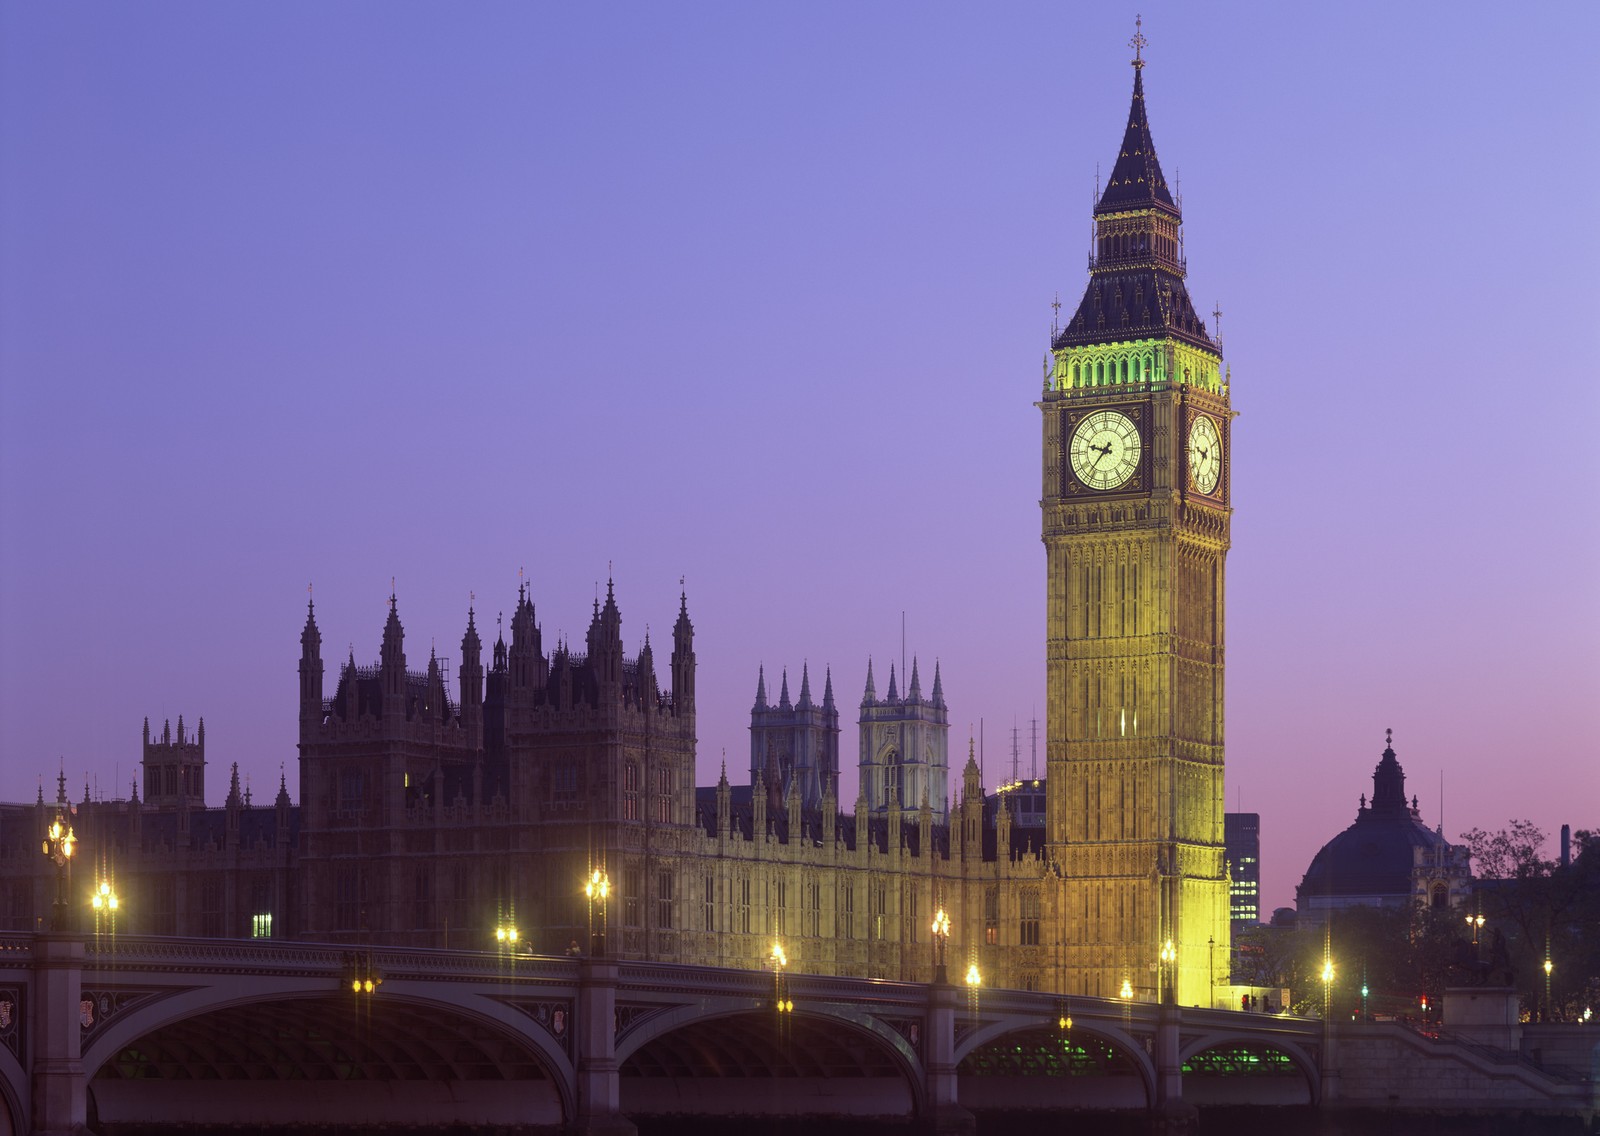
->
[616,997,926,1120]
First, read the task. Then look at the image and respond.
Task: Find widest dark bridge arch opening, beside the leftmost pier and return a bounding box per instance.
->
[83,978,576,1126]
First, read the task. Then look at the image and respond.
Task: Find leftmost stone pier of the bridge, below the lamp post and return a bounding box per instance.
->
[29,933,88,1136]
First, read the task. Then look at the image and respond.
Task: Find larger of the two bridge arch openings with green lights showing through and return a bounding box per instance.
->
[955,1016,1155,1110]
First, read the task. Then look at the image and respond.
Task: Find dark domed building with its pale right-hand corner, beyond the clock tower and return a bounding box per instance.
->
[1294,730,1472,926]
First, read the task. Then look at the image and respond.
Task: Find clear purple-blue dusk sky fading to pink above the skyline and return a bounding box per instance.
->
[0,0,1600,907]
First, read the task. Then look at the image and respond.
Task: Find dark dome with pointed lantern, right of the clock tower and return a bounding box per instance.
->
[1294,734,1450,909]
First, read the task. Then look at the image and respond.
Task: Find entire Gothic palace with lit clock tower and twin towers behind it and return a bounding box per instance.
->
[0,37,1232,1003]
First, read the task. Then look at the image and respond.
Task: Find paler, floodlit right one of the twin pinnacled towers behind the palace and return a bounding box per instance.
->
[858,659,950,824]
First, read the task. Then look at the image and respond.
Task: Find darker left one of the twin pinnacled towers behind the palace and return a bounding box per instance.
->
[750,664,838,813]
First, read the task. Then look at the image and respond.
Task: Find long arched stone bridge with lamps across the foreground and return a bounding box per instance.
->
[0,934,1600,1136]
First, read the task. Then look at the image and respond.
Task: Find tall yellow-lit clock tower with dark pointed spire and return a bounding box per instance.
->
[1038,35,1234,1005]
